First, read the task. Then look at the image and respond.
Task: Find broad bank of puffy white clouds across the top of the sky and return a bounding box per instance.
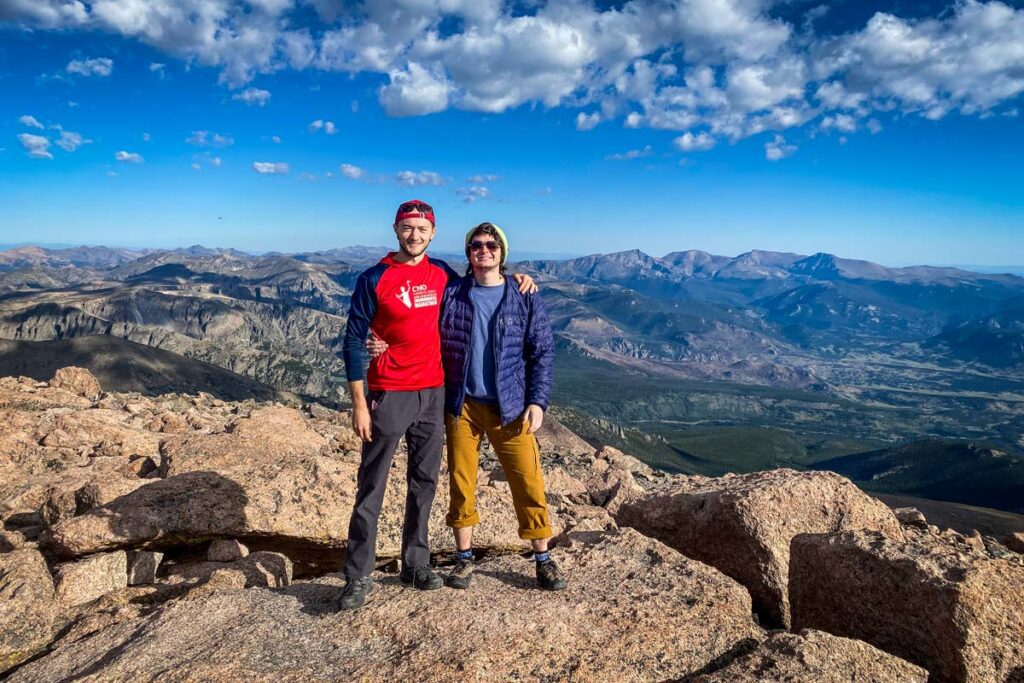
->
[8,0,1024,153]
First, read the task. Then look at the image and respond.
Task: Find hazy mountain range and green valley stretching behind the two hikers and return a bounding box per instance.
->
[0,240,1024,505]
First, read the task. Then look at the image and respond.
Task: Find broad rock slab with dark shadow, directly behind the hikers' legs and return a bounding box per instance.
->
[45,417,561,557]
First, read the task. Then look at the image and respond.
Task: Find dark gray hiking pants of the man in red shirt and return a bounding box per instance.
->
[345,387,444,579]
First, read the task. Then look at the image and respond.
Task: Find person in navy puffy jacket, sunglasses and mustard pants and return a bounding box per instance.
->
[440,223,566,591]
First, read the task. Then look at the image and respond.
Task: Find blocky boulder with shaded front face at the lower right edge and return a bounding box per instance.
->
[790,531,1024,683]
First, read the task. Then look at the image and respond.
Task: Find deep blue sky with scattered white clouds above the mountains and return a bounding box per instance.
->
[0,0,1024,266]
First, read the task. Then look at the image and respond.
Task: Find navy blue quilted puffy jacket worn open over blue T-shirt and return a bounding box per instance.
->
[440,275,555,425]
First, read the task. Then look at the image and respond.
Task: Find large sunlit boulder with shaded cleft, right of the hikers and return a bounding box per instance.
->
[615,469,902,627]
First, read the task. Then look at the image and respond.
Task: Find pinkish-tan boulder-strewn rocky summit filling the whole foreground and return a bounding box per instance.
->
[0,368,1024,683]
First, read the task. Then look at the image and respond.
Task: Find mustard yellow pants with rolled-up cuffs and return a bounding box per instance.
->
[444,399,551,541]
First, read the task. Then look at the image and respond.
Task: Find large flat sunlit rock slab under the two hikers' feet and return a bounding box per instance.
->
[10,529,763,683]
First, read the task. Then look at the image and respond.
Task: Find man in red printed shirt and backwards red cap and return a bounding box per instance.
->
[341,200,536,609]
